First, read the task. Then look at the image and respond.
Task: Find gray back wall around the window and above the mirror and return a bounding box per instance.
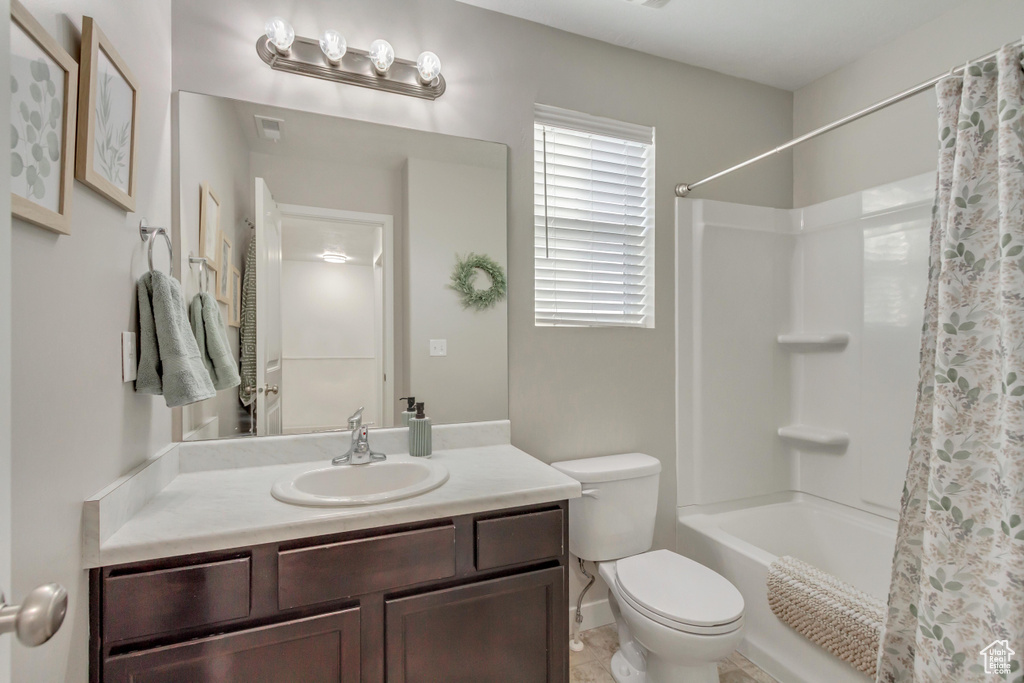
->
[173,0,793,565]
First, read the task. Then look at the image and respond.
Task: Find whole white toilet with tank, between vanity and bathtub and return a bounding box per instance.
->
[552,453,743,683]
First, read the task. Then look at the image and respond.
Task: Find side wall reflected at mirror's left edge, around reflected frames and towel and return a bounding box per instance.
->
[177,93,254,436]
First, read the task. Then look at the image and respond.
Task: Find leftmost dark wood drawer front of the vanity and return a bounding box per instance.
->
[102,557,250,641]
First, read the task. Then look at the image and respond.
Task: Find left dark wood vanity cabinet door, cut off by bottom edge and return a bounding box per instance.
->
[102,608,359,683]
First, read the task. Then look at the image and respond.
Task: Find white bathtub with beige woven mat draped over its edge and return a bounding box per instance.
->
[677,493,896,683]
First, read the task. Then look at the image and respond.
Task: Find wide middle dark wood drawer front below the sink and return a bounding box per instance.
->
[278,524,455,609]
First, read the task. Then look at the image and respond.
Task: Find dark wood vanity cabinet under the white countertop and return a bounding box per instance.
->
[90,502,568,683]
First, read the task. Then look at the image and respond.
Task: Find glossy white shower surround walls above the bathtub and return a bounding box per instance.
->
[678,174,935,518]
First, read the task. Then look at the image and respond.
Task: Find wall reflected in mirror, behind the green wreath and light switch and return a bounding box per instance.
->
[406,158,509,423]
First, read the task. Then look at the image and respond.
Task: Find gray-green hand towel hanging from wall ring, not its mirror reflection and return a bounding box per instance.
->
[135,270,217,408]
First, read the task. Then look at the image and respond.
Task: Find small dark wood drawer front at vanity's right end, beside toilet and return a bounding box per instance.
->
[476,509,564,569]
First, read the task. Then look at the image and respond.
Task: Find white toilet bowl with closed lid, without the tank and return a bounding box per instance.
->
[598,550,743,683]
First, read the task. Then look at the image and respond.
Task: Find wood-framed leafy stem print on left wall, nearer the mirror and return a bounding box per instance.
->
[75,16,138,211]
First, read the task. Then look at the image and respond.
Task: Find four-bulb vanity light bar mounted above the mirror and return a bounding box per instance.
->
[256,16,445,99]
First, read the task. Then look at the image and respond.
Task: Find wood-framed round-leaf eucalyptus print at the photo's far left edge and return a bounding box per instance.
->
[10,0,78,234]
